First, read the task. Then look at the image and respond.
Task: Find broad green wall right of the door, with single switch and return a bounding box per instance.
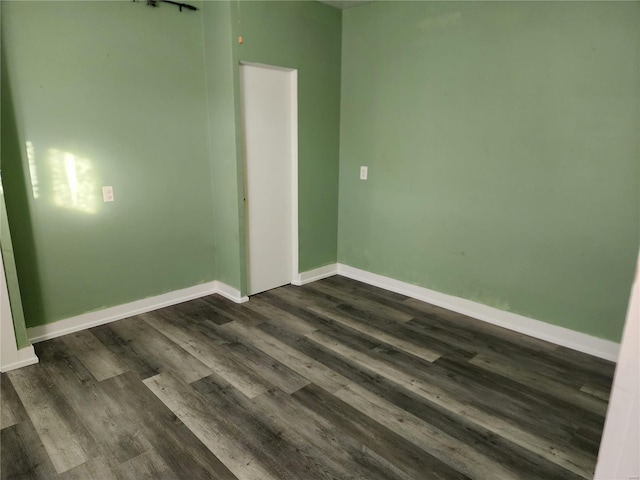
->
[338,2,640,341]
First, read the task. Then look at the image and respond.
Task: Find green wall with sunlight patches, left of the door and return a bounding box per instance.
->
[2,1,215,326]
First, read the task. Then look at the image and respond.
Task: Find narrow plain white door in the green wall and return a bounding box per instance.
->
[240,65,297,295]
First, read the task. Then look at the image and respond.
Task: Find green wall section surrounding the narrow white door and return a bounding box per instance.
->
[231,1,342,278]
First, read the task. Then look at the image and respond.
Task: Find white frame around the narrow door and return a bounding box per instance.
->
[238,61,300,295]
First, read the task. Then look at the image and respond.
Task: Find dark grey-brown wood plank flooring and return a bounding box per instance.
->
[1,276,614,480]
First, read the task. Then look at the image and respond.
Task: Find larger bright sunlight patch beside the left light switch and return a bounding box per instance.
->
[49,148,98,213]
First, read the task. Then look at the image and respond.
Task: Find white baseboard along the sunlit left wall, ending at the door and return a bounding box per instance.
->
[27,280,249,343]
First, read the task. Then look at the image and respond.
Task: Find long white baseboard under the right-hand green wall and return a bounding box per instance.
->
[338,263,620,362]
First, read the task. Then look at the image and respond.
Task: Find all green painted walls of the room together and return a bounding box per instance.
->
[1,1,640,340]
